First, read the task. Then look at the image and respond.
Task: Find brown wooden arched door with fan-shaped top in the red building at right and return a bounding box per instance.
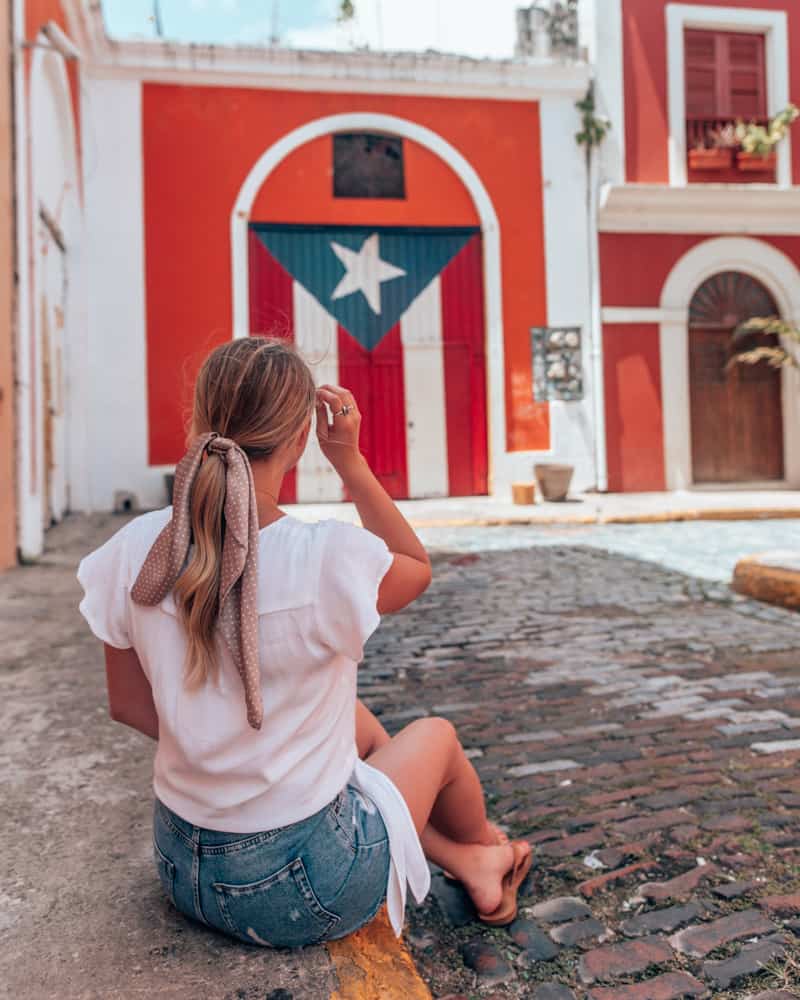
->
[689,271,783,483]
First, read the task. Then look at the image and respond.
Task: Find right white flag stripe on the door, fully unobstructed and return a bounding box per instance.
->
[400,277,449,497]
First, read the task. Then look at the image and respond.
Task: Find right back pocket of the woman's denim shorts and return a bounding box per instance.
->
[212,858,340,948]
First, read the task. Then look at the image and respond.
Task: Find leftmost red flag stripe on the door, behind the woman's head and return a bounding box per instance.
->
[248,229,297,503]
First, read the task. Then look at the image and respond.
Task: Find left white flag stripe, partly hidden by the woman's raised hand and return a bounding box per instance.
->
[292,281,343,503]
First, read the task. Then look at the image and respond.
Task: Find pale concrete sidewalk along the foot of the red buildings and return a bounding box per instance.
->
[286,489,800,528]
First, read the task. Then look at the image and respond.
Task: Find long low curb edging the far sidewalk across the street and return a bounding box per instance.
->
[408,507,800,528]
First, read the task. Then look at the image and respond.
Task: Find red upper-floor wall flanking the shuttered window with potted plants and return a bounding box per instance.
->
[622,0,800,184]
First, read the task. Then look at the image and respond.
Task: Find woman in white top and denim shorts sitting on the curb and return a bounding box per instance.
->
[78,337,531,946]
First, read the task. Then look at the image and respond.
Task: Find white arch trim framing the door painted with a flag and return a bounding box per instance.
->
[231,112,506,493]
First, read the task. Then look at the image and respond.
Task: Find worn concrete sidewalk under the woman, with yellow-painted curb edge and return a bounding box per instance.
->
[0,515,430,1000]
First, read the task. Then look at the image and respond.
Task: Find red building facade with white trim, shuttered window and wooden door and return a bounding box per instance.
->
[597,0,800,491]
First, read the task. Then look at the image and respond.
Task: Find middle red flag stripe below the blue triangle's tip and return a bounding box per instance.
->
[339,324,408,500]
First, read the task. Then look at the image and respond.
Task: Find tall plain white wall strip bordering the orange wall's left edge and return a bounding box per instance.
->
[82,77,165,510]
